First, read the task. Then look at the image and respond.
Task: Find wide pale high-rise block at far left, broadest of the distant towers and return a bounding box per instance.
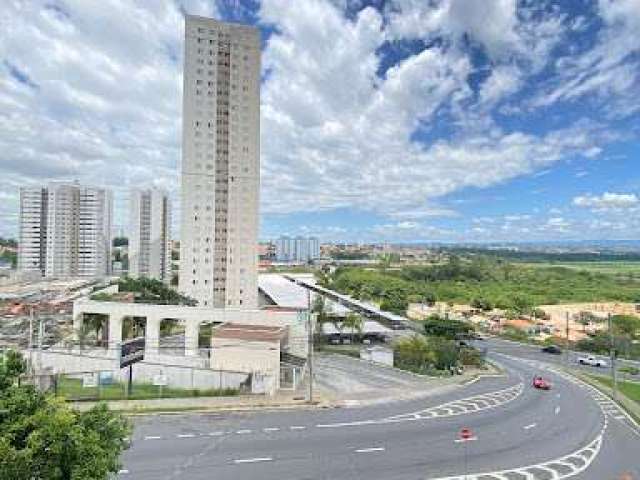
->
[19,182,113,278]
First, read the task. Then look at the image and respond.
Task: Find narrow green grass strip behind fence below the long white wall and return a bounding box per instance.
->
[57,377,238,400]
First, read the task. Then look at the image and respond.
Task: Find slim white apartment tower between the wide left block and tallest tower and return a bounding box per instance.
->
[129,188,171,283]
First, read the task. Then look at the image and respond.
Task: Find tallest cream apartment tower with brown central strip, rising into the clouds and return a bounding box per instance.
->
[179,15,260,308]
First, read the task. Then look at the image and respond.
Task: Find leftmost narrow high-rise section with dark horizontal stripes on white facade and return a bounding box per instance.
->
[18,187,48,276]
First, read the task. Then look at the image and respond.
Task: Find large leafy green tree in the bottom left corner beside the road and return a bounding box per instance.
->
[0,352,130,480]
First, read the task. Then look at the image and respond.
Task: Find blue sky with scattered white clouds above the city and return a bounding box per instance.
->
[0,0,640,242]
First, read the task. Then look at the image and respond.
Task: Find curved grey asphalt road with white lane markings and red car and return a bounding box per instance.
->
[120,346,640,480]
